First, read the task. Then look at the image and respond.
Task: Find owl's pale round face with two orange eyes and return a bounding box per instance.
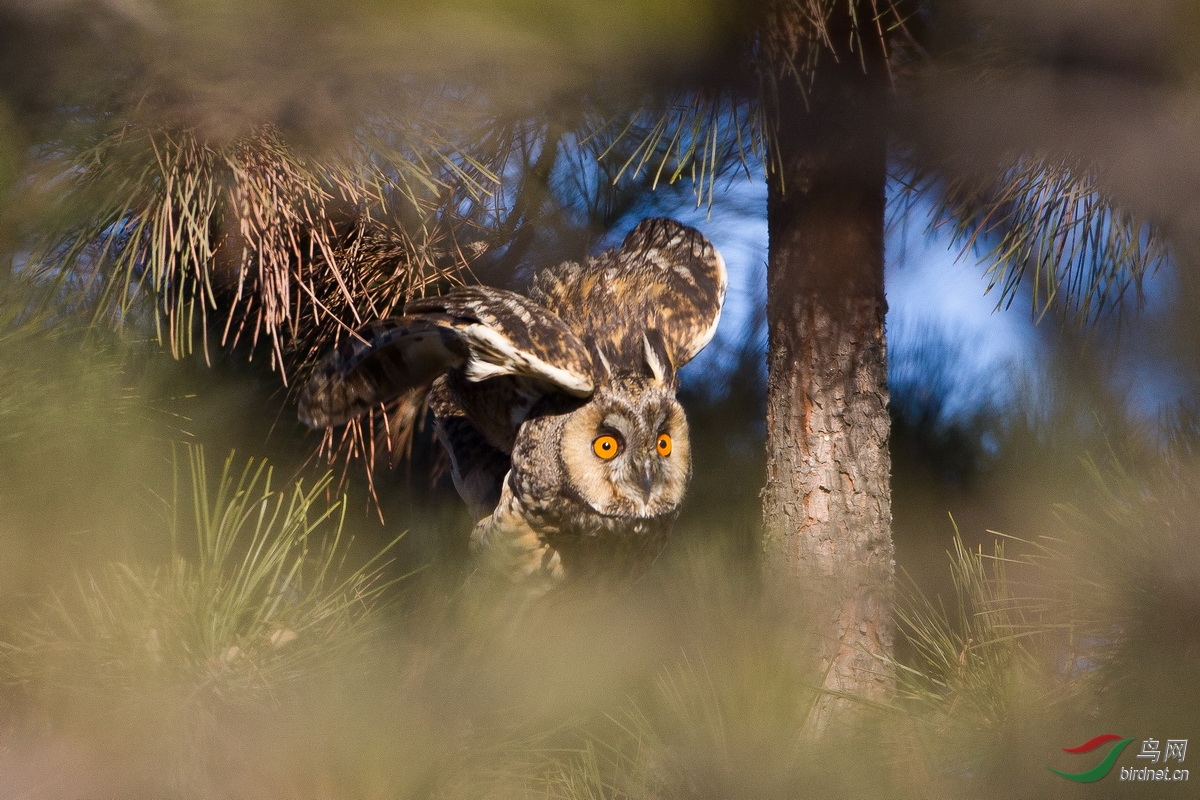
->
[558,375,691,519]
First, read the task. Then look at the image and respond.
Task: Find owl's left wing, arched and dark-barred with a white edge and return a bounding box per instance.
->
[299,287,594,428]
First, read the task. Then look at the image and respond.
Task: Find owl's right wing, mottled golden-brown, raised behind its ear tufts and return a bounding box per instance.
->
[530,217,728,372]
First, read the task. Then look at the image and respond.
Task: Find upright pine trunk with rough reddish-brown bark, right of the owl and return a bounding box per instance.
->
[763,8,893,727]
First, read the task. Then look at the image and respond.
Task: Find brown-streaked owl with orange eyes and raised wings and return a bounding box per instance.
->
[299,218,727,585]
